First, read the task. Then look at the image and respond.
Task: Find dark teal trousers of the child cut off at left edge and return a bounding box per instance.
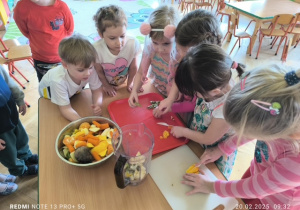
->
[0,120,32,176]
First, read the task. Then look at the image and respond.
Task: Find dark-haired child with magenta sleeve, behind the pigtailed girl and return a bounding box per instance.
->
[153,9,222,117]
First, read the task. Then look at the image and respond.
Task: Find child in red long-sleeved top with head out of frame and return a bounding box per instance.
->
[14,0,74,82]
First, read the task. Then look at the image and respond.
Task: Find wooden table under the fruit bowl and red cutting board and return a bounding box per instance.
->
[39,83,243,210]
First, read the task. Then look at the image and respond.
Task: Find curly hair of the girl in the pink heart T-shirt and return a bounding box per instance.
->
[93,5,127,34]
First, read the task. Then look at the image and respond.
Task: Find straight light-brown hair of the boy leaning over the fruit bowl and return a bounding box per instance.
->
[58,34,97,68]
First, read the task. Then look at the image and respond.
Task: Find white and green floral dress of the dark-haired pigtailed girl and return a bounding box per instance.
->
[190,94,237,179]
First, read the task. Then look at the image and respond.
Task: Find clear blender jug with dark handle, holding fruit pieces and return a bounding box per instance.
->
[113,123,154,189]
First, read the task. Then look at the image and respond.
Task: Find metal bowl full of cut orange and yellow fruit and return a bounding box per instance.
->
[55,116,122,167]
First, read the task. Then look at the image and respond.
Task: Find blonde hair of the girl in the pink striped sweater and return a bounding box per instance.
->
[224,65,300,143]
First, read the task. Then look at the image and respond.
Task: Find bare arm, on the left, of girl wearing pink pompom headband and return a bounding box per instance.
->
[128,54,151,107]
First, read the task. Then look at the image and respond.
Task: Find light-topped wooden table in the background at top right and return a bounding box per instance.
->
[226,0,300,53]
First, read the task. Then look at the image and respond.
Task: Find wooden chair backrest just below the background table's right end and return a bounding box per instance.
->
[269,14,295,36]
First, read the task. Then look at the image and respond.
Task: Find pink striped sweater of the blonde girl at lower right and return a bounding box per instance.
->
[214,138,300,209]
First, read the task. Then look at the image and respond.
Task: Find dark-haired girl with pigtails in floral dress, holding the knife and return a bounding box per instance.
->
[171,44,243,178]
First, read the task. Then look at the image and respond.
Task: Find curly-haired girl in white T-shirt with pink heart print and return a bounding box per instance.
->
[94,5,140,96]
